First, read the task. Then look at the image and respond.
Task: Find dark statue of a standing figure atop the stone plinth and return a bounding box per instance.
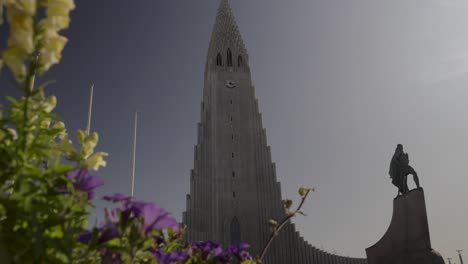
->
[388,144,420,196]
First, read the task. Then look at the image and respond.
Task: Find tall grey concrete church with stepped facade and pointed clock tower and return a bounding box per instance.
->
[183,0,366,264]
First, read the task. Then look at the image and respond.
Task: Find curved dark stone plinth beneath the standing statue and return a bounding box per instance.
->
[366,188,444,264]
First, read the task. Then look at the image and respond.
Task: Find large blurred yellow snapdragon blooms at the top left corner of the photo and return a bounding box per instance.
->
[0,0,75,82]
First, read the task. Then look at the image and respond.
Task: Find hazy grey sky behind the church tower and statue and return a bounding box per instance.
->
[0,0,468,258]
